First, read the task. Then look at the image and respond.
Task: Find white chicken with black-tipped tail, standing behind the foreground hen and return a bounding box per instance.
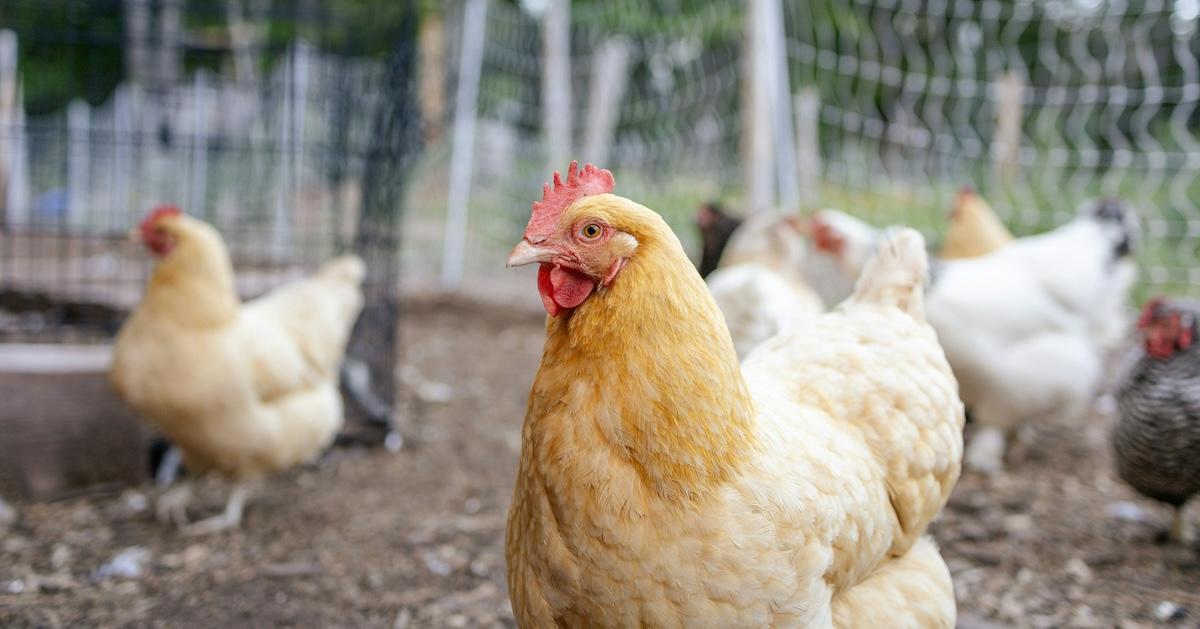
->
[926,199,1136,473]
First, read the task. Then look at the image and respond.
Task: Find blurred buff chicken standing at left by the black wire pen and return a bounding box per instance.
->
[109,208,365,534]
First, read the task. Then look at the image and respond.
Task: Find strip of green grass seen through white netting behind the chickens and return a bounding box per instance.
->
[396,148,1200,304]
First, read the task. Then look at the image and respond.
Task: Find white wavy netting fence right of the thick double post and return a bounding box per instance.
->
[786,0,1200,297]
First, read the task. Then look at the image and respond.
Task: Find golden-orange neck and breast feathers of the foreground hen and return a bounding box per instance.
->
[527,213,755,499]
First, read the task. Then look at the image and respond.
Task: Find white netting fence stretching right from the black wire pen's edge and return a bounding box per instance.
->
[409,0,1200,303]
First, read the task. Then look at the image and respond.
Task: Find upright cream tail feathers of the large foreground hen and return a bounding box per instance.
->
[852,228,929,321]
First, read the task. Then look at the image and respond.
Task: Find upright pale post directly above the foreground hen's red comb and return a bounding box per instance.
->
[541,0,572,170]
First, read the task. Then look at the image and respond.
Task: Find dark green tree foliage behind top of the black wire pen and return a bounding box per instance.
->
[0,0,442,115]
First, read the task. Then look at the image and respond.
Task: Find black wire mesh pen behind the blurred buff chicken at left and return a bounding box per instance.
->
[0,0,421,410]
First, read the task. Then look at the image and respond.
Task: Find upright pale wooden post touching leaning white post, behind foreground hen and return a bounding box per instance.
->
[742,0,776,214]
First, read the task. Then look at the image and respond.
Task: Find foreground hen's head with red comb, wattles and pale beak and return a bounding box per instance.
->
[509,162,637,317]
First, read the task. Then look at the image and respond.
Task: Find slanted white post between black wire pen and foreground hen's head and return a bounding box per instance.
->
[442,0,487,289]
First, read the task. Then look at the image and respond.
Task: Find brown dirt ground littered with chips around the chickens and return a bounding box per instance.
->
[0,300,1200,628]
